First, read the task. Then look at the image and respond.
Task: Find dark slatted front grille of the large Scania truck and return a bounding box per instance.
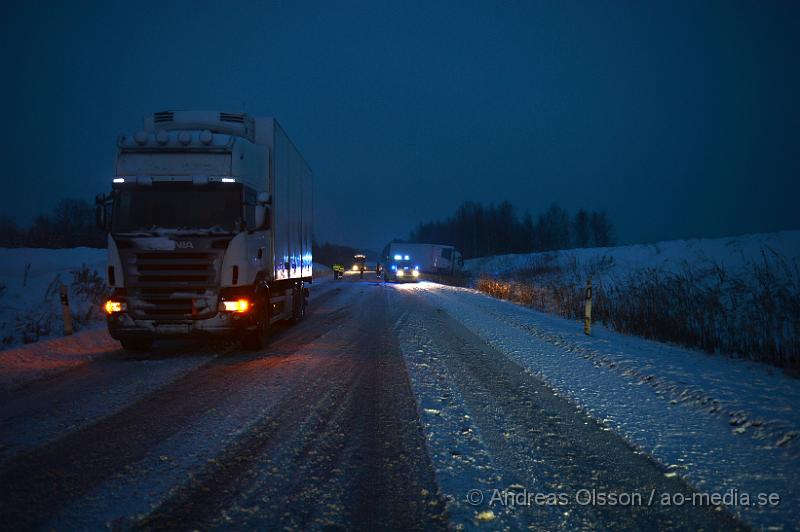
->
[126,250,222,321]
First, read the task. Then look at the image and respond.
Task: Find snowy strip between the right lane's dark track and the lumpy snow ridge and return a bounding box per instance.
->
[419,286,800,527]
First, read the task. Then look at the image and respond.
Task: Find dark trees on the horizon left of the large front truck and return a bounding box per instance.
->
[0,199,106,248]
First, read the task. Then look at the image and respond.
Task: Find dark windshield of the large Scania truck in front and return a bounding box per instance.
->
[111,183,242,234]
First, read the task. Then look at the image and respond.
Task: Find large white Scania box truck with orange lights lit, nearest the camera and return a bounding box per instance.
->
[97,111,312,350]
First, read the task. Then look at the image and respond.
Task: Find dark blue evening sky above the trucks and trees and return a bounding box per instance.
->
[0,0,800,249]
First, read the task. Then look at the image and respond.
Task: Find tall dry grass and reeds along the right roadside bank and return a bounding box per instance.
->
[474,250,800,373]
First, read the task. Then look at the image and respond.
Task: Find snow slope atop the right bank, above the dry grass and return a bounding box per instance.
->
[464,231,800,280]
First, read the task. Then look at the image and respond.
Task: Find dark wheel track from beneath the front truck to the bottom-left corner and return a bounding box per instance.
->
[0,280,354,528]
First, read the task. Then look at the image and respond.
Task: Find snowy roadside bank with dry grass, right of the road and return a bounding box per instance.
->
[466,231,800,371]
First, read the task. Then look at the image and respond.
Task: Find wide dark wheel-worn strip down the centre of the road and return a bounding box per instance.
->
[141,285,445,530]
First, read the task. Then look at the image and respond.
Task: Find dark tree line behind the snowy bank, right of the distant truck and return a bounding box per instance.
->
[410,201,614,259]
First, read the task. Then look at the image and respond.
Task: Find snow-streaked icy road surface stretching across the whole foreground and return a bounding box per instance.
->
[0,275,800,530]
